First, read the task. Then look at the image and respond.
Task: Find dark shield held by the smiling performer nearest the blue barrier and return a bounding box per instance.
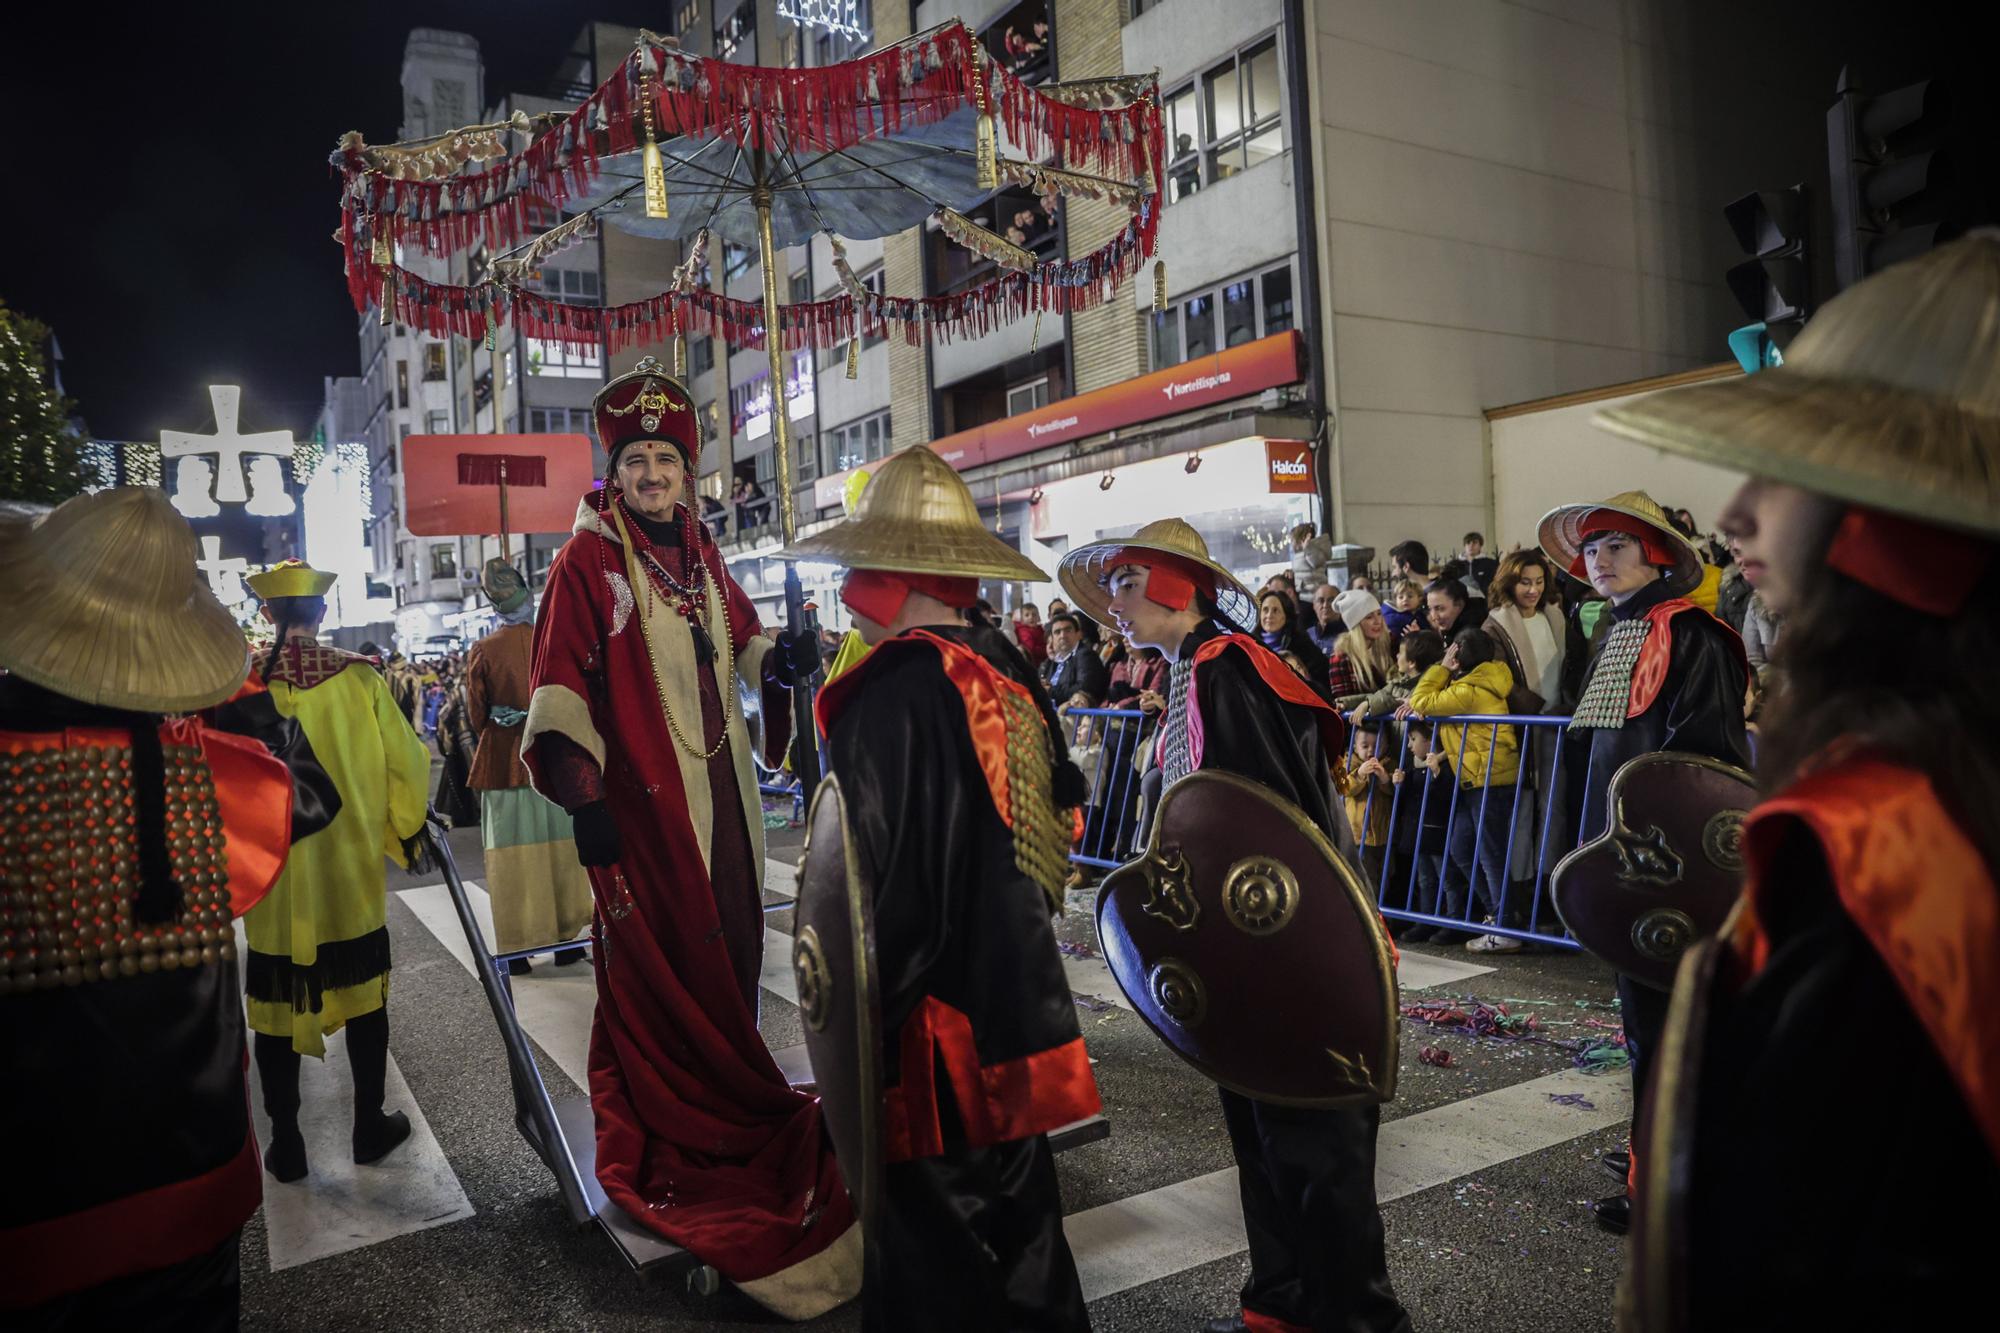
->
[1550,751,1756,991]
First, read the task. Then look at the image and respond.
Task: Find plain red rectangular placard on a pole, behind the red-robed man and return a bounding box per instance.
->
[402,434,596,536]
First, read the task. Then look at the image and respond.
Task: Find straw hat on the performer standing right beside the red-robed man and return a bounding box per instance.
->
[784,444,1048,582]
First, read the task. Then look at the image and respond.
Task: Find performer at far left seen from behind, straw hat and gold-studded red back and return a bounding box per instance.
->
[0,486,314,1329]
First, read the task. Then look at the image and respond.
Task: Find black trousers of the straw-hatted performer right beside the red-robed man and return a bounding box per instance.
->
[862,1135,1090,1333]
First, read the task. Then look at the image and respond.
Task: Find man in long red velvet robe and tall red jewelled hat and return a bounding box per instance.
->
[522,356,860,1319]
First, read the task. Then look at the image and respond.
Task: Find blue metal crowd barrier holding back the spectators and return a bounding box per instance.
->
[1066,709,1590,949]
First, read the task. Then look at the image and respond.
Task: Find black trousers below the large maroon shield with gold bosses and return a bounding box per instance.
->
[1222,1089,1410,1333]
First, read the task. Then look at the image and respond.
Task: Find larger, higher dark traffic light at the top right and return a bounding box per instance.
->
[1826,70,1964,288]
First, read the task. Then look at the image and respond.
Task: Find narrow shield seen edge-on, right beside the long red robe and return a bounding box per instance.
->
[792,777,884,1233]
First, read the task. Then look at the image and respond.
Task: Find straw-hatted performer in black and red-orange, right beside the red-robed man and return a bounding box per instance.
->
[788,446,1100,1333]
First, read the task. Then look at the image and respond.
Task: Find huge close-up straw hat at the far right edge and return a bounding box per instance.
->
[1596,228,2000,536]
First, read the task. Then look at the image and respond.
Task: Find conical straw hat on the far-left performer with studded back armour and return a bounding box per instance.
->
[0,486,250,713]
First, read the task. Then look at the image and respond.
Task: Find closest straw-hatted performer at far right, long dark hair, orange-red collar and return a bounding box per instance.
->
[1598,228,2000,1333]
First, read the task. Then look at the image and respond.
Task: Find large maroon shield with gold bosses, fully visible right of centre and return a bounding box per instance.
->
[1098,771,1400,1107]
